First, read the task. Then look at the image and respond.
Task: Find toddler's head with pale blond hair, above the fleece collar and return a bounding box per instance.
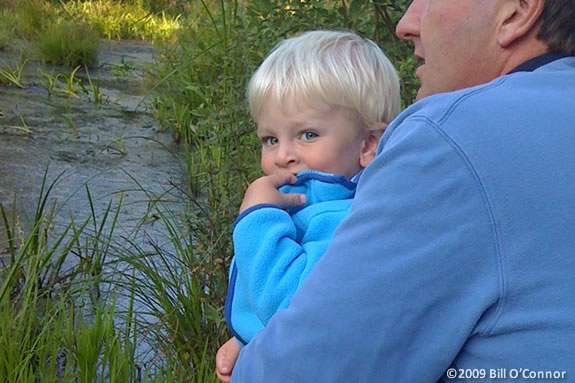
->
[247,31,400,177]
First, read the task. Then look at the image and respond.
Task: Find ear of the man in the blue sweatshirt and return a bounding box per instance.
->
[497,0,545,48]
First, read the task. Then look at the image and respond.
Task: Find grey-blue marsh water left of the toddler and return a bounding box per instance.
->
[0,41,185,366]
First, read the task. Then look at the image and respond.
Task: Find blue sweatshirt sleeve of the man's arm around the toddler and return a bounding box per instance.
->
[232,118,501,383]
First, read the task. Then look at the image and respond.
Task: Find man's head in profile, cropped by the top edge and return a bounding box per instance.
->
[397,0,575,99]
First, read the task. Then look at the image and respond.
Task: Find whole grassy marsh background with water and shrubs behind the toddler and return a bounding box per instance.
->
[0,0,414,382]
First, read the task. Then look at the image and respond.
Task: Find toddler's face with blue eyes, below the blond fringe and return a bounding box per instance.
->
[257,100,377,178]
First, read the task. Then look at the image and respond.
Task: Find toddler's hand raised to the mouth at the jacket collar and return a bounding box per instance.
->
[240,172,305,214]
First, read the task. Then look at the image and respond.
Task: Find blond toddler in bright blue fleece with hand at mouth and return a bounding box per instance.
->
[225,31,400,345]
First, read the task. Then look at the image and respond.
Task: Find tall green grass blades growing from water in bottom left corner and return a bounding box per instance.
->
[0,173,134,382]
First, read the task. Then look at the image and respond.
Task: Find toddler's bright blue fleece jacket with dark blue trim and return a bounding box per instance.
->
[225,170,357,344]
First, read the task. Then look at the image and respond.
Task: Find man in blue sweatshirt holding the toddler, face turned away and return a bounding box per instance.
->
[219,0,575,383]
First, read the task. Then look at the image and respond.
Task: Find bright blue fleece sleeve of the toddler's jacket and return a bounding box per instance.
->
[233,205,344,325]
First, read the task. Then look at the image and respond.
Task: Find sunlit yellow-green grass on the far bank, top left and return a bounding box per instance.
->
[0,0,182,67]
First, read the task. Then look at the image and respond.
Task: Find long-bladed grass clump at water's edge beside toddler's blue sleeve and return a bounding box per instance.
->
[117,204,226,383]
